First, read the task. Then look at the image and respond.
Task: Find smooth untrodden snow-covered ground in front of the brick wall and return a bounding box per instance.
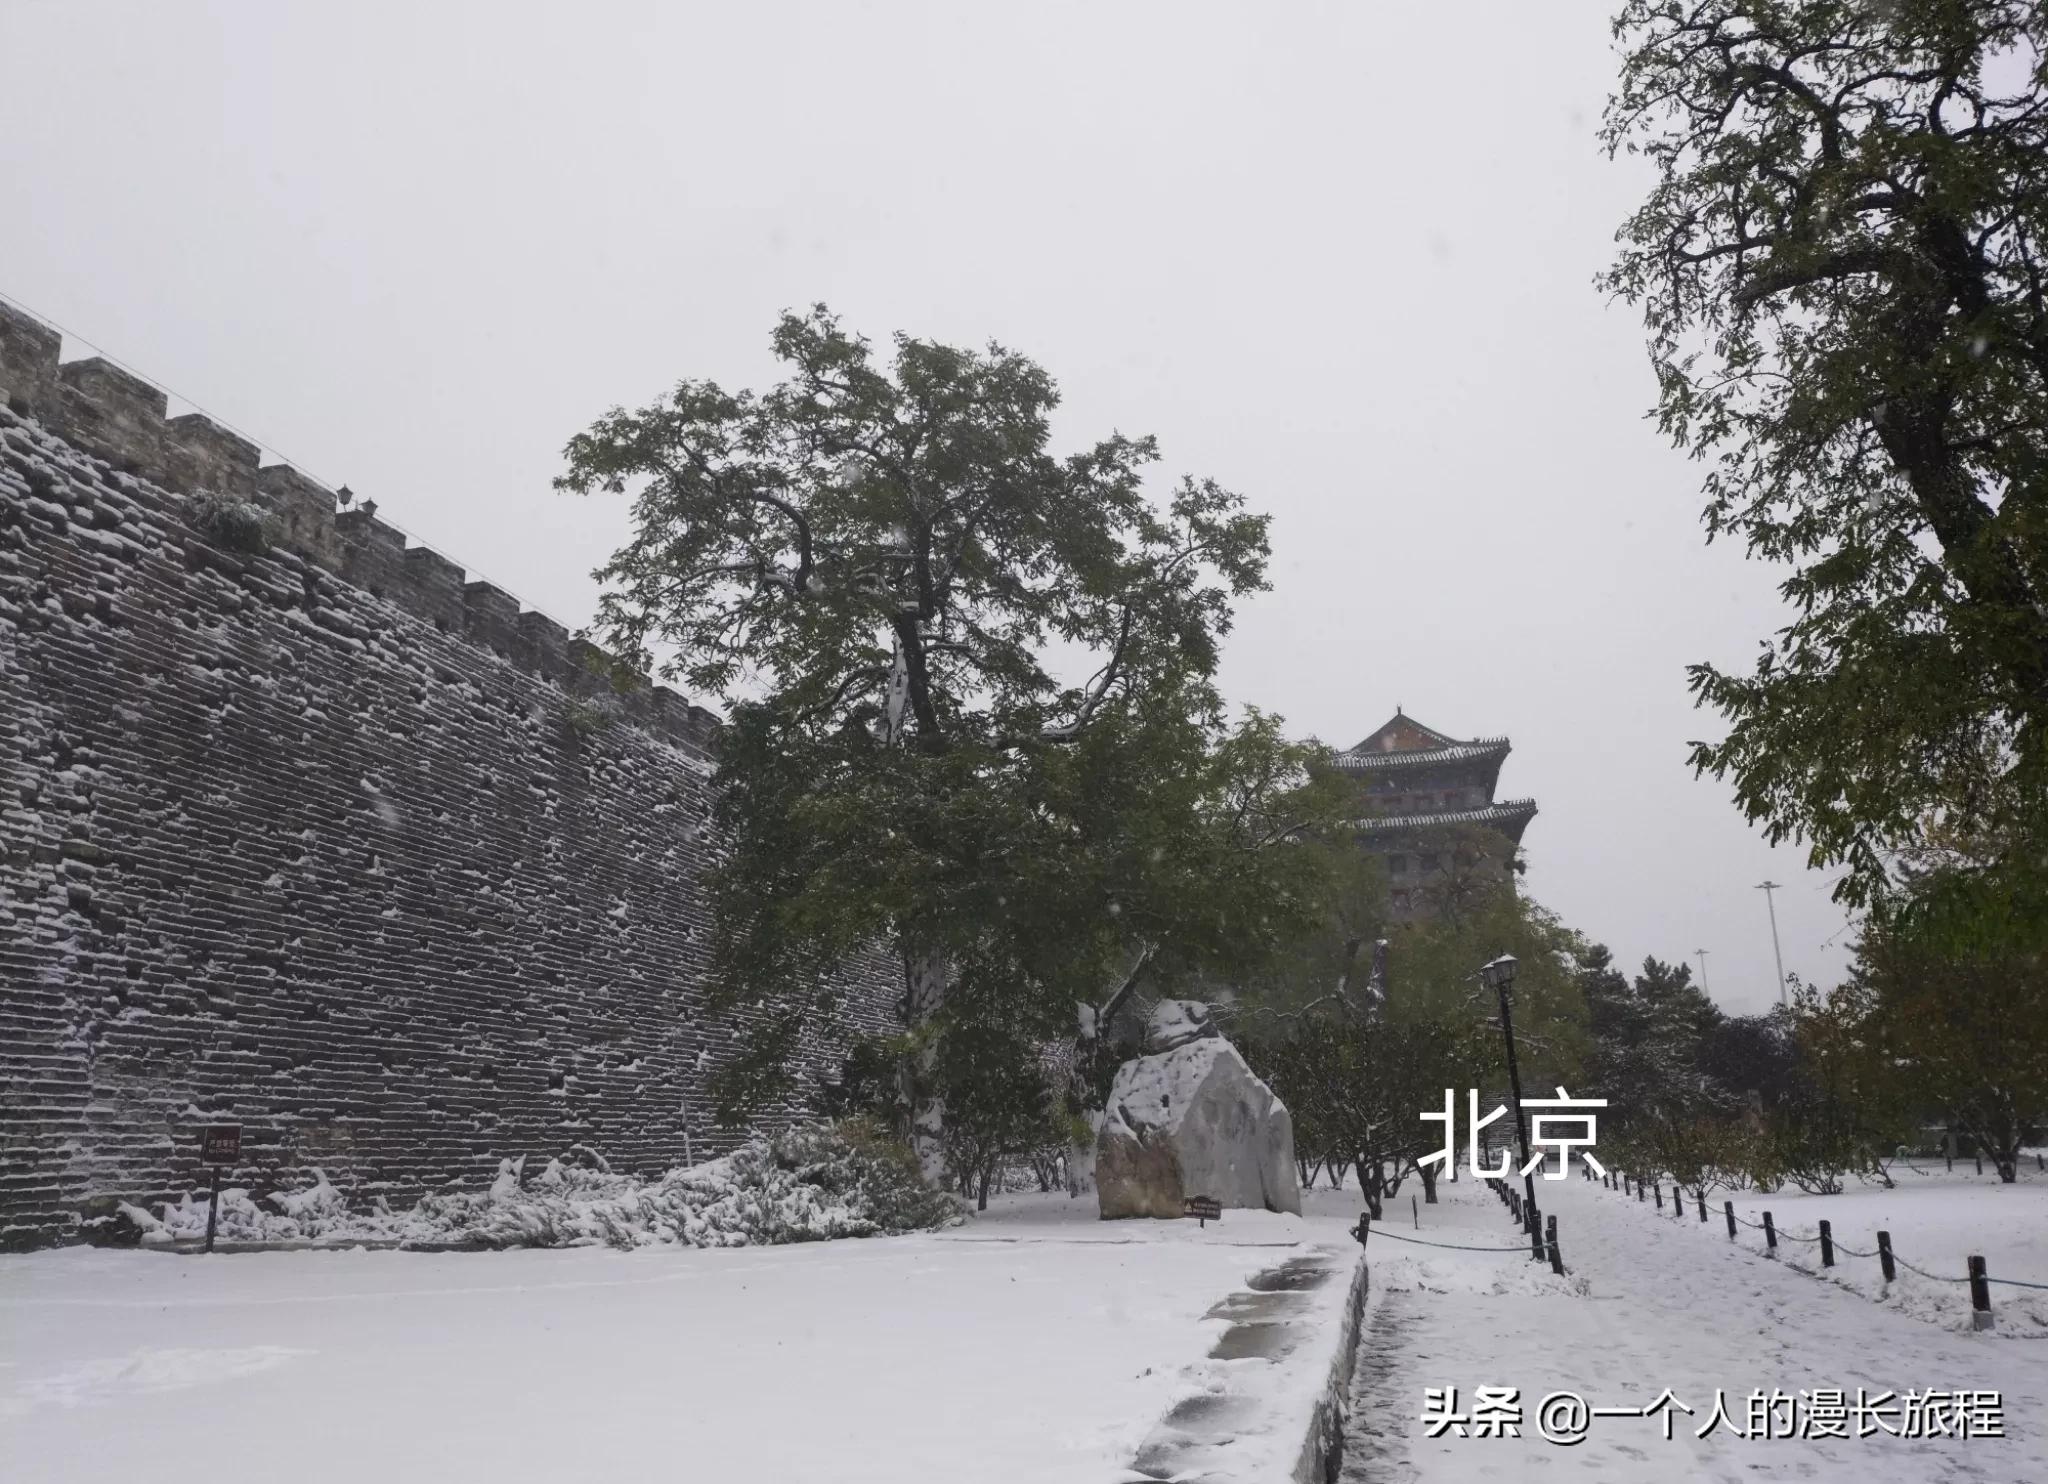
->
[0,1195,1356,1484]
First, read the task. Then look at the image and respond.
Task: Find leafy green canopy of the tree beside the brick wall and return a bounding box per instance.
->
[557,307,1317,1154]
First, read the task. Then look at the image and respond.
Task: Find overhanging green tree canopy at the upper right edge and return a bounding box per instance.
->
[1604,0,2048,931]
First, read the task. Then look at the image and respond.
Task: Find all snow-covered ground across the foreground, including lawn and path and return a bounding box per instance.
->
[12,1175,2048,1484]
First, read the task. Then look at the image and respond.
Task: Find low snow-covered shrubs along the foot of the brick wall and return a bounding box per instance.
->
[123,1120,961,1247]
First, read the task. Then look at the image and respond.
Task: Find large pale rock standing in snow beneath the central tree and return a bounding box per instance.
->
[1096,1001,1300,1220]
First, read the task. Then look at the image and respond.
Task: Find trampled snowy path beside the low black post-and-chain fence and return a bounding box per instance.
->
[1343,1179,2048,1484]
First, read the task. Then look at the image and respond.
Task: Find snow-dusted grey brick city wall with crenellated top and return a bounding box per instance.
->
[0,305,897,1247]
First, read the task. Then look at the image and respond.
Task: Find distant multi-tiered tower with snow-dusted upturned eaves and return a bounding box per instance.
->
[1337,708,1536,921]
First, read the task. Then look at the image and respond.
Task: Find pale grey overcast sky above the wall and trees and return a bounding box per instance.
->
[0,0,1851,1011]
